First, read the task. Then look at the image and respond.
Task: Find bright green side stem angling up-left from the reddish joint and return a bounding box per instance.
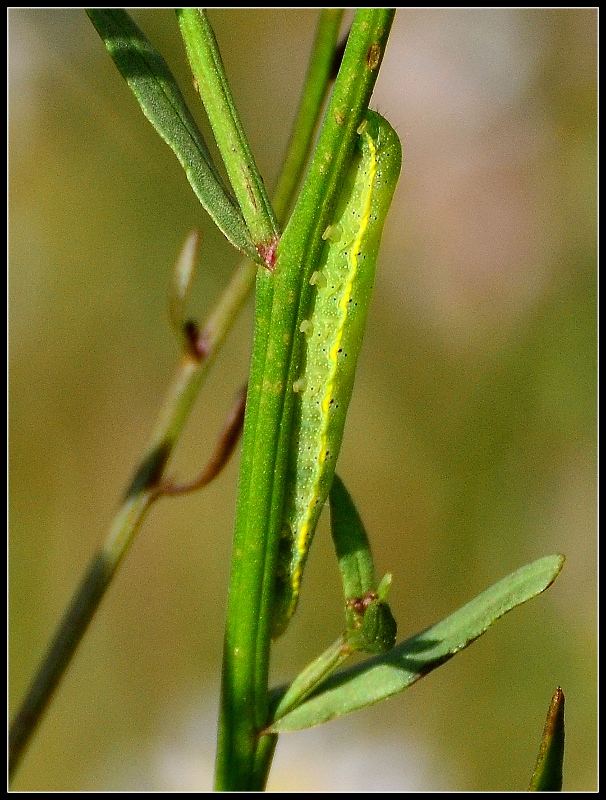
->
[177,8,278,264]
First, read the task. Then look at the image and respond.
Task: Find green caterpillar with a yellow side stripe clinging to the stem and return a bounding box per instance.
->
[272,111,402,638]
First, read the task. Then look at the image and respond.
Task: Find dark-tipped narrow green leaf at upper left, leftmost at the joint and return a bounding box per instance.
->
[87,8,262,263]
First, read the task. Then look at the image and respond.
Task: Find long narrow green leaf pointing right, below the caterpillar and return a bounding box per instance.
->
[267,555,564,733]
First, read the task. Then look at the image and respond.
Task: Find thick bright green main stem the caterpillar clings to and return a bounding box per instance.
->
[215,9,394,791]
